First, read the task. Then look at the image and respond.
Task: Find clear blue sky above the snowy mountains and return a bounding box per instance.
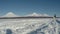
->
[0,0,60,16]
